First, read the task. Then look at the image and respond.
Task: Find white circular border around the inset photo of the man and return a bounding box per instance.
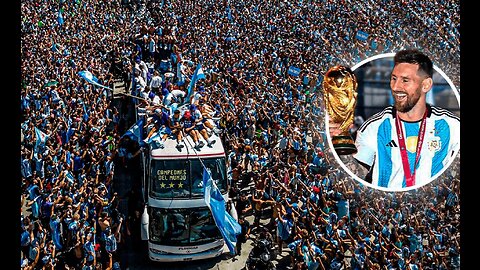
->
[325,53,460,192]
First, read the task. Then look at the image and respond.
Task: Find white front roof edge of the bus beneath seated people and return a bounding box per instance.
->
[151,133,225,160]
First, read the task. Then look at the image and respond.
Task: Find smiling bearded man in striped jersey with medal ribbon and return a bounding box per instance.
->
[353,49,460,190]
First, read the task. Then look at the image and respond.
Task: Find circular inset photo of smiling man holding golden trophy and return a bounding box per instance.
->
[322,49,460,191]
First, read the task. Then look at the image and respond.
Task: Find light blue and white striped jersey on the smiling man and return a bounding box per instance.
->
[353,104,460,190]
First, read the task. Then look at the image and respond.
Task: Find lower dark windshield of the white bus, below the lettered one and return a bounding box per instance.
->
[150,207,222,246]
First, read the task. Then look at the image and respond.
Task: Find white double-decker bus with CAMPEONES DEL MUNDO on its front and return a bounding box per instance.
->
[140,106,228,262]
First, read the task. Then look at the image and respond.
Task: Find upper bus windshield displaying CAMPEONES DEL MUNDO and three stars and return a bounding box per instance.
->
[150,157,227,199]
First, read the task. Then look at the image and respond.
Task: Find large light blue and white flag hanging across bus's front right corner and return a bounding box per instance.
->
[203,166,242,255]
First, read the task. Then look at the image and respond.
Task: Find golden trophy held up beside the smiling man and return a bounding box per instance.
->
[322,66,357,155]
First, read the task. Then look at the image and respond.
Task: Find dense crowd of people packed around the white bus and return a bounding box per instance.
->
[21,0,460,269]
